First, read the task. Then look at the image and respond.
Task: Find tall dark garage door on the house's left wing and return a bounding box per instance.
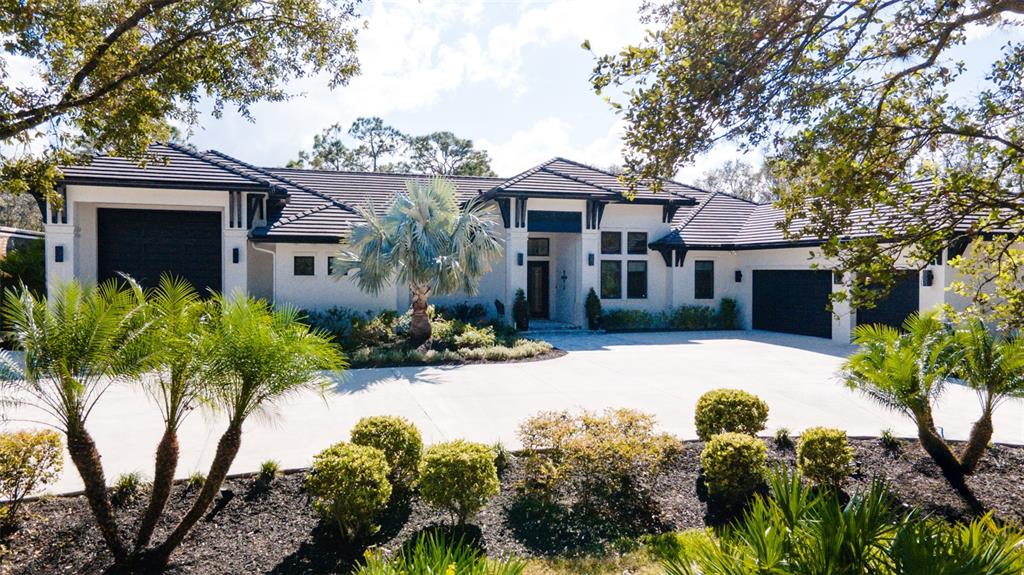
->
[96,208,221,294]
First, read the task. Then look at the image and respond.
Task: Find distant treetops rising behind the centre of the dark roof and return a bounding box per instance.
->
[288,117,495,176]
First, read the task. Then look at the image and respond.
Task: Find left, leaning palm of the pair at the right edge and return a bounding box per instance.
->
[842,312,981,510]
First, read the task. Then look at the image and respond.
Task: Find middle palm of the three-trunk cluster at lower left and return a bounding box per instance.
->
[135,276,211,551]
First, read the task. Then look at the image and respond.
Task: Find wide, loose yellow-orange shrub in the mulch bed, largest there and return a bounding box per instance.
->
[519,409,678,524]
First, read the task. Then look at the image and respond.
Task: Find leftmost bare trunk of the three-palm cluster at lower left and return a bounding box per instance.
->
[68,422,128,565]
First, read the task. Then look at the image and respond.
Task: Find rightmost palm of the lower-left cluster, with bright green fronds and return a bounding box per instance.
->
[146,297,345,568]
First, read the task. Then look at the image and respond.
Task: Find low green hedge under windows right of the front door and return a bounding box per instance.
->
[601,298,739,331]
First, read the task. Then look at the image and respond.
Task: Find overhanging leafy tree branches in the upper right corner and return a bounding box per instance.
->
[592,0,1024,327]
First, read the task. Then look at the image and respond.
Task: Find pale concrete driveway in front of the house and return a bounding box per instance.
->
[2,331,1024,492]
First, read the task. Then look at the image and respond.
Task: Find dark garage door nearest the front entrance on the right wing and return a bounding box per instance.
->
[753,269,831,338]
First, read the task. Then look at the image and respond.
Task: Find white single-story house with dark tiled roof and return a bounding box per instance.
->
[46,143,955,341]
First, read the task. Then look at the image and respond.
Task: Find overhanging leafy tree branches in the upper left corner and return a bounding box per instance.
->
[0,0,358,204]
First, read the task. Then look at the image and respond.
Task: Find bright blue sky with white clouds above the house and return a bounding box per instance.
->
[165,0,1021,180]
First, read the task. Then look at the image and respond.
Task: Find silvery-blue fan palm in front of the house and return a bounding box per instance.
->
[342,177,502,345]
